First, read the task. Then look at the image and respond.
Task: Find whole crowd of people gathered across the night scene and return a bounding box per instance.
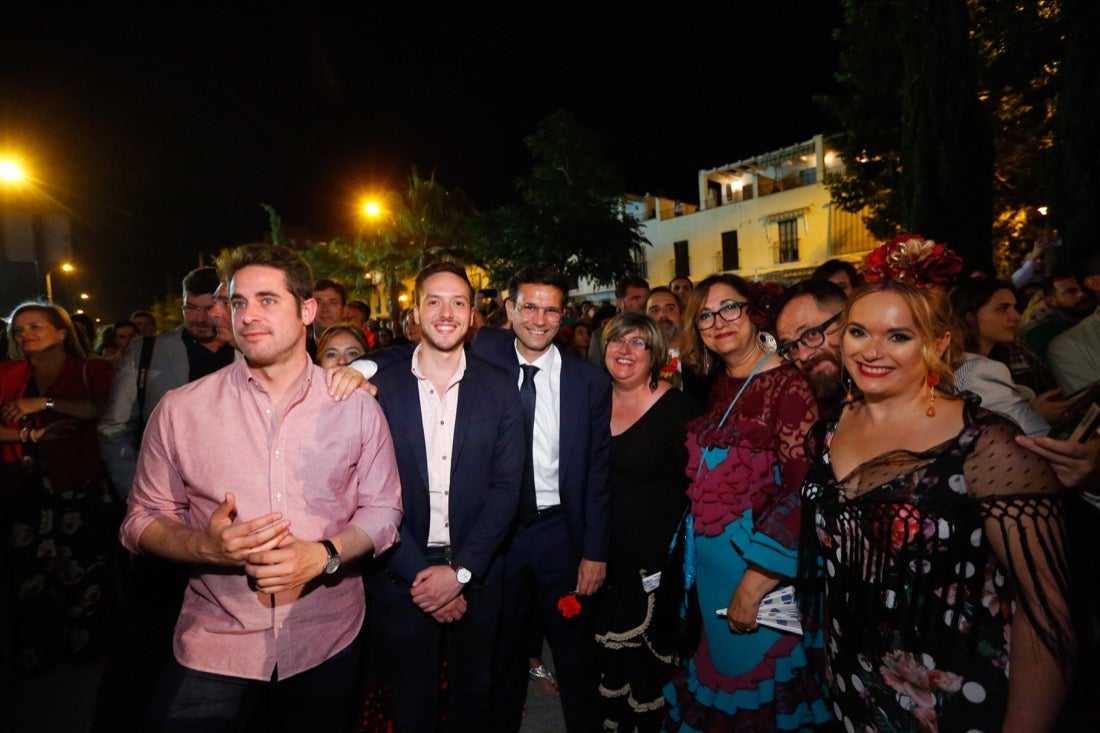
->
[0,234,1100,733]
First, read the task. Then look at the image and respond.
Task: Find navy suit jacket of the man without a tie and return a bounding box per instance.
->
[367,355,526,594]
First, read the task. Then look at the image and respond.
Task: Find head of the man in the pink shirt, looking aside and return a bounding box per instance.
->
[229,265,317,368]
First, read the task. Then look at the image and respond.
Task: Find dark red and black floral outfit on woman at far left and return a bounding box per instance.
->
[0,357,119,672]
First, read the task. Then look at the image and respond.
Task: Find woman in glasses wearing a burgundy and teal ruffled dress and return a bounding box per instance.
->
[666,274,829,731]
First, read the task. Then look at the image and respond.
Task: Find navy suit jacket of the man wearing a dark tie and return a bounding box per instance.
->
[470,328,612,562]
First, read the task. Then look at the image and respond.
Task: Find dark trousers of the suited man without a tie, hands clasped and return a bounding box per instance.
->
[366,581,501,733]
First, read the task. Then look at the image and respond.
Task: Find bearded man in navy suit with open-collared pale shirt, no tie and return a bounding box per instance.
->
[366,263,525,732]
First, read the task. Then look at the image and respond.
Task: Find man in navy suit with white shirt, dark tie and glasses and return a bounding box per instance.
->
[471,259,611,733]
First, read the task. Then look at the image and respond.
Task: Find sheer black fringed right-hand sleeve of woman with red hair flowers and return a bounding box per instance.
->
[964,420,1074,666]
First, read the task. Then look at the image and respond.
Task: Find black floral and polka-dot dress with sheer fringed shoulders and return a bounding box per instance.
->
[802,406,1070,733]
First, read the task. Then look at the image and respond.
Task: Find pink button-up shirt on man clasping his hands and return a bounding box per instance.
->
[121,361,402,679]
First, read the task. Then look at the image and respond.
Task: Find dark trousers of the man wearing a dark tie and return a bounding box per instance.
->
[490,515,601,733]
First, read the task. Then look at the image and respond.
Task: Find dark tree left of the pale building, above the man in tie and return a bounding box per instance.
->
[471,110,648,285]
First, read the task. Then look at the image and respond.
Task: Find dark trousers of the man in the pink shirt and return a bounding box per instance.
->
[143,642,360,733]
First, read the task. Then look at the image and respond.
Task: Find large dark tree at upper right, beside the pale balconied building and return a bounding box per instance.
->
[823,0,1062,273]
